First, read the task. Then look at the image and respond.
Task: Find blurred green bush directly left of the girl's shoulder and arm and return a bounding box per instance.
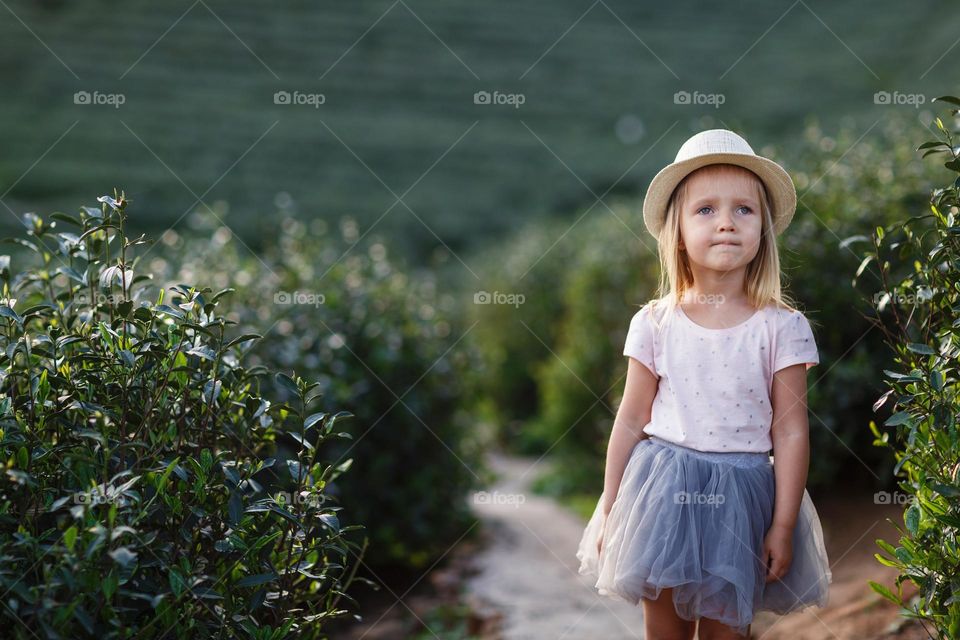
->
[530,200,656,493]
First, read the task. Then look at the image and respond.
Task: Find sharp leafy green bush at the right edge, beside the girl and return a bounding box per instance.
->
[864,96,960,640]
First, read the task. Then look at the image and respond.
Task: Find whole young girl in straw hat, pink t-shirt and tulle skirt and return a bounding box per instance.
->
[577,129,832,640]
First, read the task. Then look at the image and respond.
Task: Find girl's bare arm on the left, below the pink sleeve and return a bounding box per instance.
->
[603,358,659,514]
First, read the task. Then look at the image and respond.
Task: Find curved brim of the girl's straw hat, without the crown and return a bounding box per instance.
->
[643,153,797,239]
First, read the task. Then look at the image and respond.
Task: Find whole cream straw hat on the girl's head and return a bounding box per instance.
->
[643,129,797,238]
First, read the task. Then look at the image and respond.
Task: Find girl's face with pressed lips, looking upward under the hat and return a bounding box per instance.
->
[680,165,763,277]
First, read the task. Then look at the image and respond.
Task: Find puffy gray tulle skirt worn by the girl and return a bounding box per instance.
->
[577,437,833,634]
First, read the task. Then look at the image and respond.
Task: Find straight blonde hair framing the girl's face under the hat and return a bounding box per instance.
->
[650,163,796,328]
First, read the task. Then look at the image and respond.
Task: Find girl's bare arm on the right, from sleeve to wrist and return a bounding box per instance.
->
[770,363,810,533]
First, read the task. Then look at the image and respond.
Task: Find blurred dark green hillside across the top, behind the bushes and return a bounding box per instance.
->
[0,0,957,260]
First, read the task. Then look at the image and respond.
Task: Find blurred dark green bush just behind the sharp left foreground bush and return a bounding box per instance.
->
[149,209,486,575]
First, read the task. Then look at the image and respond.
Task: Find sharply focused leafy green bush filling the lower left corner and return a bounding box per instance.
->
[0,194,362,639]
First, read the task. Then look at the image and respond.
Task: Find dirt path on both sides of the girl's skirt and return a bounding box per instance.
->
[466,455,927,640]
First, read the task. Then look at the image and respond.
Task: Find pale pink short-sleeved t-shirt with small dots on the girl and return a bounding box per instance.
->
[623,301,820,452]
